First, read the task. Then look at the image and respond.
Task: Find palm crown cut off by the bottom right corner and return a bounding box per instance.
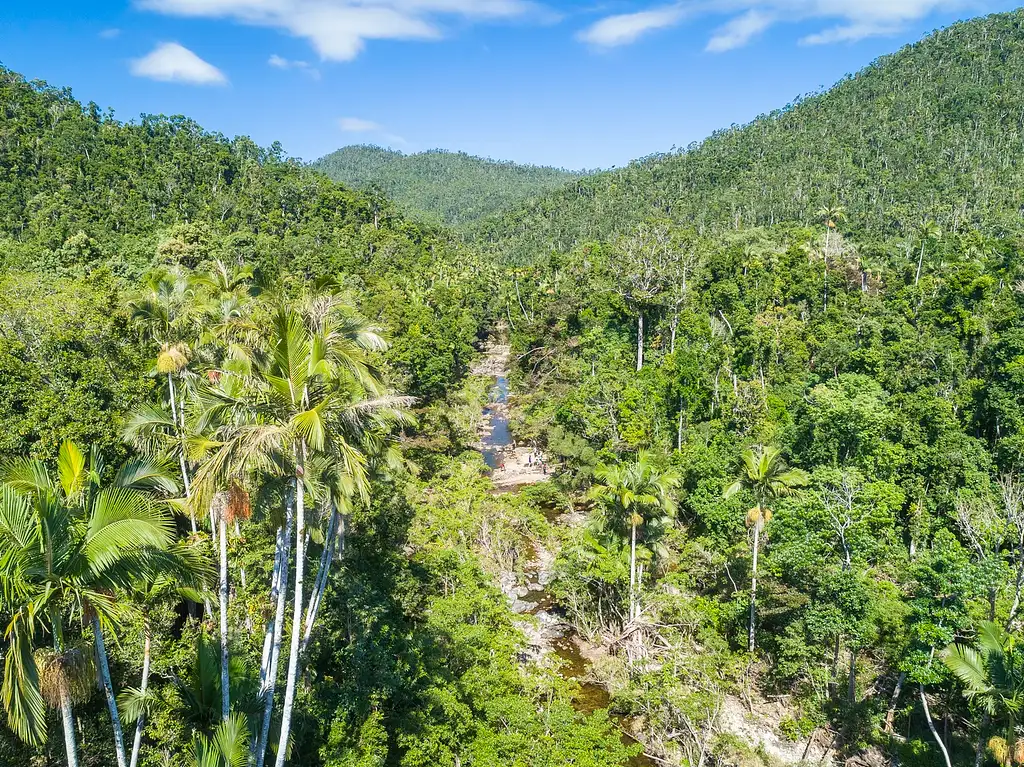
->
[942,622,1024,767]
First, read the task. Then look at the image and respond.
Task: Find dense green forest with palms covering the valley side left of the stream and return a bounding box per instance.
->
[0,64,627,767]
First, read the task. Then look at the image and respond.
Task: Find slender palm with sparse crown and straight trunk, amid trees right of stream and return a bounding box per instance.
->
[723,445,808,652]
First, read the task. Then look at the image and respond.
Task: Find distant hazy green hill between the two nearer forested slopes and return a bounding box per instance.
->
[313,145,583,226]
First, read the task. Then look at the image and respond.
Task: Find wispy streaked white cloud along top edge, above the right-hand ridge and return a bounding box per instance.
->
[578,0,978,53]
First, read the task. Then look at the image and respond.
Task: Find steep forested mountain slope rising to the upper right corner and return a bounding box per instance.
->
[476,11,1024,261]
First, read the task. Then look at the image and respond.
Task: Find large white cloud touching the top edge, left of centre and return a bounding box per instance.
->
[135,0,541,61]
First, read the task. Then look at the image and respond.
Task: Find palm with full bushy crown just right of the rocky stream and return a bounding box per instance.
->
[590,451,680,622]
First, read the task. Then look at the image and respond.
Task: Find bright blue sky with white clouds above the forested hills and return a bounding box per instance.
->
[0,0,1014,168]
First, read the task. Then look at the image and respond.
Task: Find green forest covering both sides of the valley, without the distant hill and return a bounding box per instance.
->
[9,7,1024,767]
